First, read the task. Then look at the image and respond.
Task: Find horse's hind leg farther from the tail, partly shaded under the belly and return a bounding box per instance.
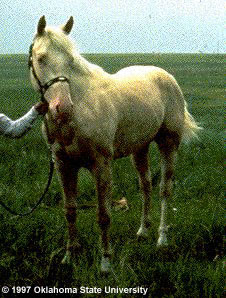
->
[133,146,152,237]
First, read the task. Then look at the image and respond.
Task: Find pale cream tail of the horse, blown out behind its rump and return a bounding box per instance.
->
[182,103,202,142]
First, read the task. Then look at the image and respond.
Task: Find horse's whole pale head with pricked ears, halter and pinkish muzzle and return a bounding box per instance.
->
[29,16,73,122]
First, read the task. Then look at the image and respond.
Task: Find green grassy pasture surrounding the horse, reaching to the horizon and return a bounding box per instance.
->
[0,54,225,297]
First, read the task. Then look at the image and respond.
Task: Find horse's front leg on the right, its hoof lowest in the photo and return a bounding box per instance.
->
[92,156,112,272]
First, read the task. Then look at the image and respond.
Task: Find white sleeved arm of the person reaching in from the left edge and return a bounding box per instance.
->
[0,107,39,138]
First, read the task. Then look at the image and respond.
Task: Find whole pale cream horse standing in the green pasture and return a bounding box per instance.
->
[30,16,201,272]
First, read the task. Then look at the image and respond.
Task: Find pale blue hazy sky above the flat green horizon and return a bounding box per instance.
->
[0,0,225,54]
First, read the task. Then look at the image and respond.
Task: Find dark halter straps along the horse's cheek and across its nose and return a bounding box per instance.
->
[28,43,69,102]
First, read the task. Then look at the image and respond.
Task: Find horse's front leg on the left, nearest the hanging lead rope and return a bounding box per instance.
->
[56,155,80,263]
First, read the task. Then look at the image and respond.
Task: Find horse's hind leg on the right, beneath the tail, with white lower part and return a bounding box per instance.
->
[156,133,179,246]
